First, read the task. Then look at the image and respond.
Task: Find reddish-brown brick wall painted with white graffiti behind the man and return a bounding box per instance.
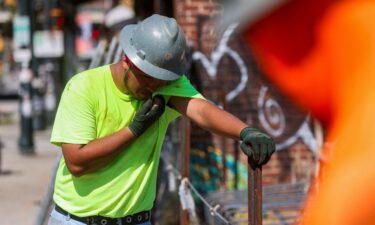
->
[173,0,315,187]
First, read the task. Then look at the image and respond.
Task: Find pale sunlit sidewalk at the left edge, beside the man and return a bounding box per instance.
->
[0,101,59,225]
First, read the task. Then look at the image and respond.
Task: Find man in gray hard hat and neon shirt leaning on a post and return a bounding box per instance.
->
[49,15,275,225]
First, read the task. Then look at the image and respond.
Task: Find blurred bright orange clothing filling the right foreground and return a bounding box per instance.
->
[245,0,375,225]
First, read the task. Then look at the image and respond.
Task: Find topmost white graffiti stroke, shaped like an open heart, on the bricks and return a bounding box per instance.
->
[193,23,249,102]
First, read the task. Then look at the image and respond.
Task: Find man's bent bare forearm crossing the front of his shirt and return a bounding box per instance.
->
[62,128,135,176]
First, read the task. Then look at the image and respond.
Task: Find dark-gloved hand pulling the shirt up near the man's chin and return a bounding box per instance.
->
[129,95,165,137]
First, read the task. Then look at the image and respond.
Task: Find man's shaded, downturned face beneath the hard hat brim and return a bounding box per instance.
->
[122,57,167,100]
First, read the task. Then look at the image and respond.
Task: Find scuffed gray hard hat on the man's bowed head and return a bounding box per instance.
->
[120,14,186,80]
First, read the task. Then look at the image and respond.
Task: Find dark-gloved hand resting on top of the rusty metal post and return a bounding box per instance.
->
[240,127,275,167]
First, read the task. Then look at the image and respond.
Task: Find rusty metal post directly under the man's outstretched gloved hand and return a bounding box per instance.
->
[248,158,262,225]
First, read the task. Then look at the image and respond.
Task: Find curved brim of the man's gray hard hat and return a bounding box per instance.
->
[120,25,182,81]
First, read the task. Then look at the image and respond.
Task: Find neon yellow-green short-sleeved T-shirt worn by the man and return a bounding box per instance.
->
[51,65,203,218]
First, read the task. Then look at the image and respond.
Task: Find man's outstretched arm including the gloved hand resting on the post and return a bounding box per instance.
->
[169,97,275,166]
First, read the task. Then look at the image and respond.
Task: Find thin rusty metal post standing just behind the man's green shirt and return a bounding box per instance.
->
[180,118,190,225]
